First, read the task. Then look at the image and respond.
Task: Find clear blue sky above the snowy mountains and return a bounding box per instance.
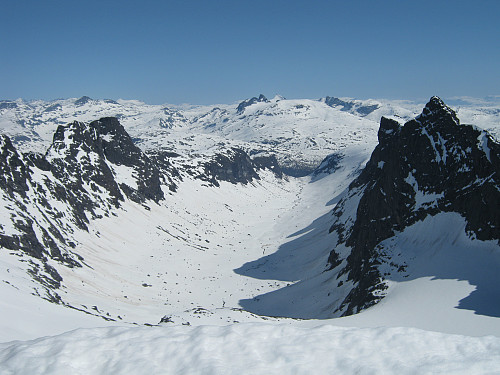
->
[0,0,500,104]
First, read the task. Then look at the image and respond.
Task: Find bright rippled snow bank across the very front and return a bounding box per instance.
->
[0,324,500,374]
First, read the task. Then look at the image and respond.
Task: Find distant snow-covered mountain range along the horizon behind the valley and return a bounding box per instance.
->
[0,95,500,175]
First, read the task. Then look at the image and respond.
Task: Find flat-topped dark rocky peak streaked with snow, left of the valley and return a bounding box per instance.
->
[45,117,163,229]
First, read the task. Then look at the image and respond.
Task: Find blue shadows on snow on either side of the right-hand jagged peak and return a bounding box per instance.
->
[234,209,500,319]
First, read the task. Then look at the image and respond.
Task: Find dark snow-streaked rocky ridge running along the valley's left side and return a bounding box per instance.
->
[0,116,281,303]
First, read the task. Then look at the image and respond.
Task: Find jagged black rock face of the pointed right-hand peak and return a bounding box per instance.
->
[329,97,500,315]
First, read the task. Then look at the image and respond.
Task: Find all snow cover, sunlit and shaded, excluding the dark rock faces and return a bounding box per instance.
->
[0,96,500,374]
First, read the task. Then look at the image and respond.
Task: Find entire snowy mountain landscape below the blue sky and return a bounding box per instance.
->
[0,95,500,374]
